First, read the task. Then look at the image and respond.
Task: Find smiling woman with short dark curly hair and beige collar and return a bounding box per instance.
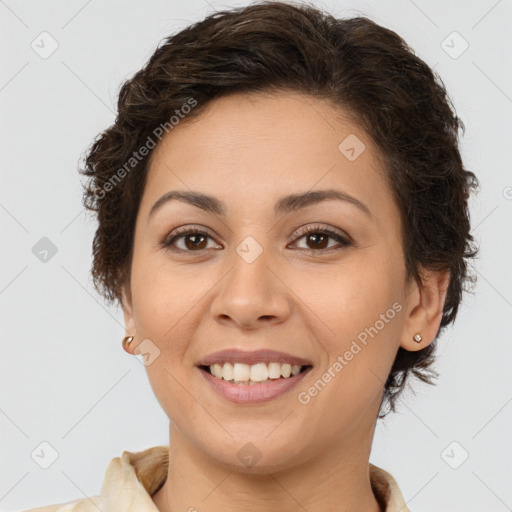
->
[25,2,478,512]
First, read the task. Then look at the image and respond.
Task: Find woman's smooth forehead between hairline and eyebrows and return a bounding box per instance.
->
[141,92,396,226]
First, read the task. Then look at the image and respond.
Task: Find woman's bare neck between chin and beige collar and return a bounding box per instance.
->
[152,414,382,512]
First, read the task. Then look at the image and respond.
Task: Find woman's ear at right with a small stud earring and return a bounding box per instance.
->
[400,270,450,352]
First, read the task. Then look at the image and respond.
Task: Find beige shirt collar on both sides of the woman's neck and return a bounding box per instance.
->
[25,446,411,512]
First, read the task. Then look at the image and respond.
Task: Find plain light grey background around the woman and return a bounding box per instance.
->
[0,0,512,512]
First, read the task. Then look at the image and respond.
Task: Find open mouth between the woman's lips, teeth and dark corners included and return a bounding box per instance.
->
[198,363,313,385]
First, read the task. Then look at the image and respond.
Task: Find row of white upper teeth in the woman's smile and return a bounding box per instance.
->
[206,363,302,382]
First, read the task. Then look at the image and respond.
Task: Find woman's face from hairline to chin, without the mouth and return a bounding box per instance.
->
[125,93,437,471]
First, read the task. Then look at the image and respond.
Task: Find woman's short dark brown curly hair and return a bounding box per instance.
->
[80,1,479,418]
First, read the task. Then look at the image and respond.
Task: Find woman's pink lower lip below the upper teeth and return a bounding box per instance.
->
[198,367,312,404]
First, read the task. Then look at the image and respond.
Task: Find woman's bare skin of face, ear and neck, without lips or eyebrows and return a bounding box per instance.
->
[123,92,448,512]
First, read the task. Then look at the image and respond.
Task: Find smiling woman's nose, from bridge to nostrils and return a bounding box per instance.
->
[211,246,292,329]
